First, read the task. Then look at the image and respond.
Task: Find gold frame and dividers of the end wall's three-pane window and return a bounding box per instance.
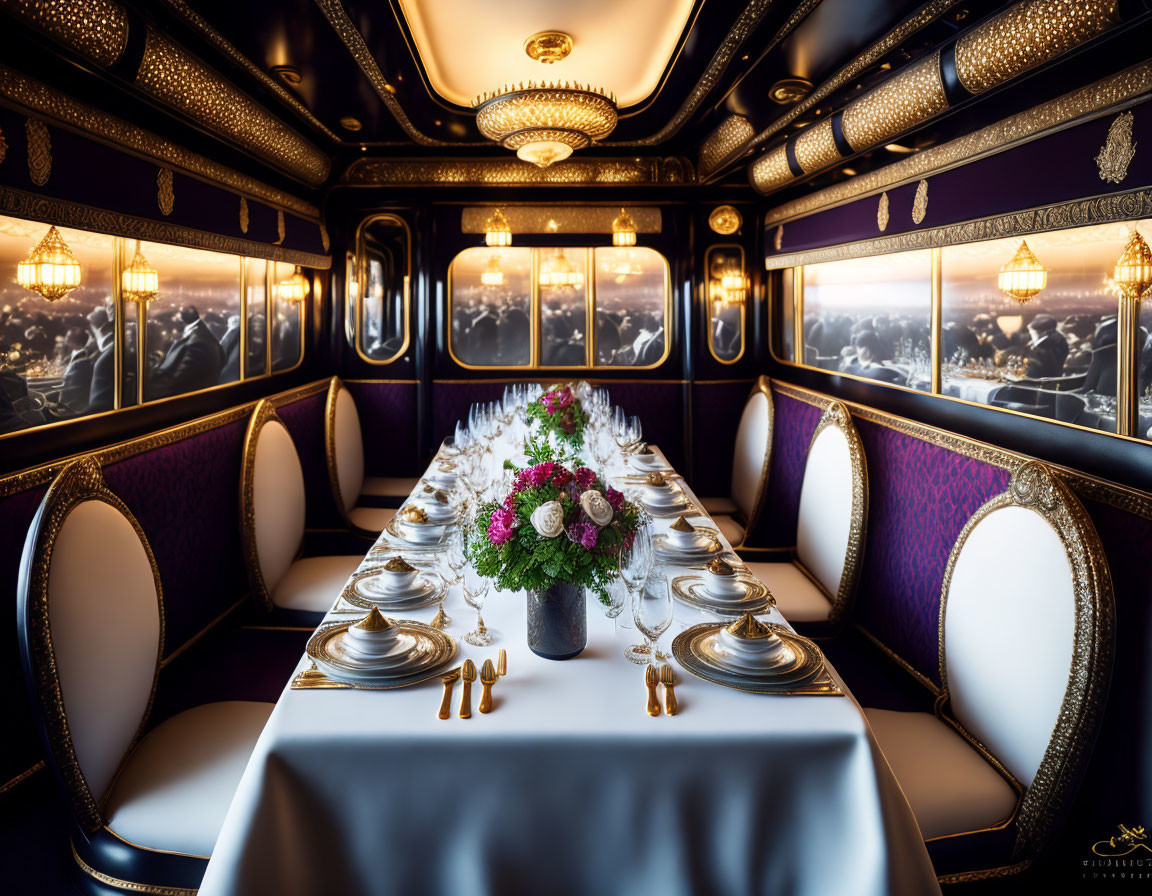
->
[445,245,673,371]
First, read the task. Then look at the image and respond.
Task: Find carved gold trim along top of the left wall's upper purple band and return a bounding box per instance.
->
[0,64,320,221]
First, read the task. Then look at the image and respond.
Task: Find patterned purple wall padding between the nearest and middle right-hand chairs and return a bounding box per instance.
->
[857,411,1009,684]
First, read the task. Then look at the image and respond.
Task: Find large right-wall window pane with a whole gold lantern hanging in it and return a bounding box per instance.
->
[940,223,1124,432]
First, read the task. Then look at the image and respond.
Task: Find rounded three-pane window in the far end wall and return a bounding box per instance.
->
[448,246,670,367]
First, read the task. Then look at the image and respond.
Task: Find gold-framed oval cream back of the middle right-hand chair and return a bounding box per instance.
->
[796,401,867,620]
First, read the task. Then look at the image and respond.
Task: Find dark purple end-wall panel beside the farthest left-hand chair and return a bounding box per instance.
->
[346,382,423,476]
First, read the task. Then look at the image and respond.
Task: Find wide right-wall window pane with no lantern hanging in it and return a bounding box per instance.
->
[802,249,932,390]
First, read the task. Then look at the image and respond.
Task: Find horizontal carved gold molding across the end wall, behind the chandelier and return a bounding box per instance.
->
[342,157,695,187]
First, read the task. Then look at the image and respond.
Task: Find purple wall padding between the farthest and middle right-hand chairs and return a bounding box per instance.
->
[750,389,824,547]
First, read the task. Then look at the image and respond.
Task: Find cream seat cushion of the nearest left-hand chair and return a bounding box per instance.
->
[106,700,273,858]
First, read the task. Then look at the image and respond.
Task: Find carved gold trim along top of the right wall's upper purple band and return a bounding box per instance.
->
[764,62,1152,226]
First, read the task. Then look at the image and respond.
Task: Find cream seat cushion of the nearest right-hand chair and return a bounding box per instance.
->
[864,709,1018,840]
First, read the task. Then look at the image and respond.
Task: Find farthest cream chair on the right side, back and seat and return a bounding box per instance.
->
[700,377,773,547]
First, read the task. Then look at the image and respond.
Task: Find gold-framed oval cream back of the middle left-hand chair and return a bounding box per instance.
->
[241,400,305,607]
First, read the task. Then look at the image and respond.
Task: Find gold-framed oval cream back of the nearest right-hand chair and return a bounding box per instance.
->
[940,462,1113,836]
